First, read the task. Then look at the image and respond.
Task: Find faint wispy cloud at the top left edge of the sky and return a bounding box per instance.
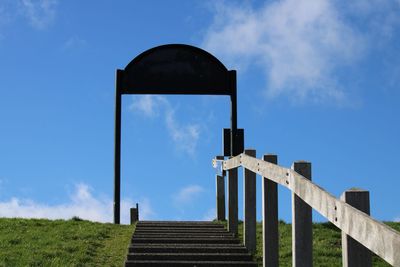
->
[20,0,57,30]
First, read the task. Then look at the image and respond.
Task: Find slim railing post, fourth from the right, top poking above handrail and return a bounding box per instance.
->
[243,149,257,253]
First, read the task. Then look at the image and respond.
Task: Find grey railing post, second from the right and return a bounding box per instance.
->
[292,161,313,267]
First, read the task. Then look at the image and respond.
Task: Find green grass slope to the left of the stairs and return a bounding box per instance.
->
[0,218,134,267]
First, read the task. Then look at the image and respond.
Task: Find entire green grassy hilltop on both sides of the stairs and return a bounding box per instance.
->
[0,218,400,267]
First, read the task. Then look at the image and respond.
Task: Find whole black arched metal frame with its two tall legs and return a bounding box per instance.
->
[114,44,238,224]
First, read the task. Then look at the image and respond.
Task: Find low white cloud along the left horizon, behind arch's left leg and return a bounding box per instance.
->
[0,183,154,224]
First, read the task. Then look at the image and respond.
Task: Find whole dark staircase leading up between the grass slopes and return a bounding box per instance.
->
[125,221,257,266]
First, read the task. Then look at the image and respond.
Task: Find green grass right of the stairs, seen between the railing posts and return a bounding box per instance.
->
[239,221,400,267]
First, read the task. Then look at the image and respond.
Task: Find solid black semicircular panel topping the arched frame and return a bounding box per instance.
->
[117,44,236,95]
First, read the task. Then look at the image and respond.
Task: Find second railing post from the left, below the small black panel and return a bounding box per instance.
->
[228,168,238,236]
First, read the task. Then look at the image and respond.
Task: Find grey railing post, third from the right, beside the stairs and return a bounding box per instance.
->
[262,155,279,267]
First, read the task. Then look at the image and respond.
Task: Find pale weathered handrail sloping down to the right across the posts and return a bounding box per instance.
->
[213,153,400,266]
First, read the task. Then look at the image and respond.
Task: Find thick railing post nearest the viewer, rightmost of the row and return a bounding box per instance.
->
[340,189,372,267]
